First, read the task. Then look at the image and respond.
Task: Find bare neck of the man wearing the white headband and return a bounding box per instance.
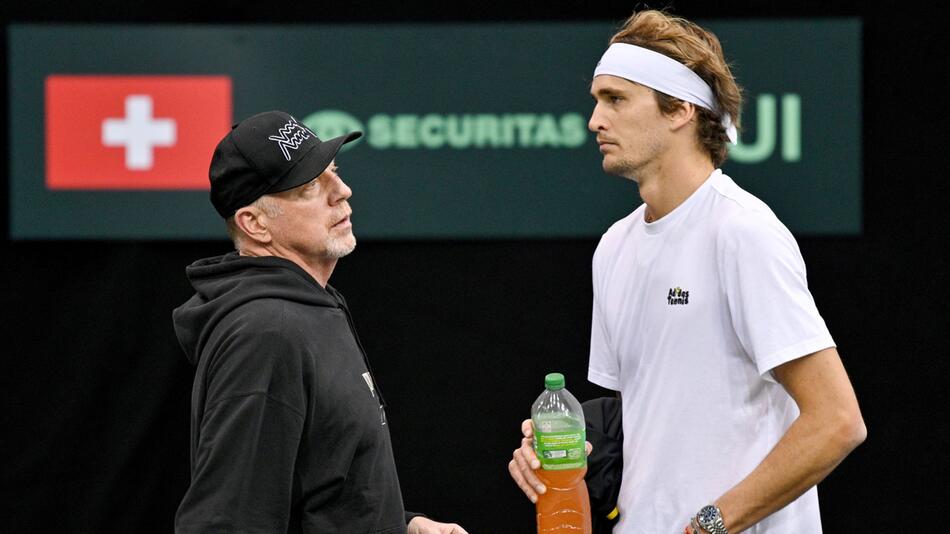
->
[637,147,715,222]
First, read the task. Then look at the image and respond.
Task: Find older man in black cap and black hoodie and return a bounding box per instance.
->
[174,111,465,534]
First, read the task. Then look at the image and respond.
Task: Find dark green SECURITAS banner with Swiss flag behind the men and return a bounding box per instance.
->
[8,19,862,239]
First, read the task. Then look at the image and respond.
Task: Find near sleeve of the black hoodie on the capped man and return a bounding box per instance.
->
[175,316,306,534]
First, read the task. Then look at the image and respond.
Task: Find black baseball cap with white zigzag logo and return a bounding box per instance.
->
[208,111,363,219]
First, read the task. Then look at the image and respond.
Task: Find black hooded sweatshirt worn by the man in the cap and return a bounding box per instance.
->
[173,253,406,534]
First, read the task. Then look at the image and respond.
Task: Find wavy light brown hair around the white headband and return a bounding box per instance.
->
[610,10,742,167]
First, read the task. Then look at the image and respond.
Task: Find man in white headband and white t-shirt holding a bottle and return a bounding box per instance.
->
[509,11,866,534]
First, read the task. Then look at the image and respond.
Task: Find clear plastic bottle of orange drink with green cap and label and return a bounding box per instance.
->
[531,373,591,534]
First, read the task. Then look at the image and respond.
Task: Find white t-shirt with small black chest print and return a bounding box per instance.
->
[588,170,834,534]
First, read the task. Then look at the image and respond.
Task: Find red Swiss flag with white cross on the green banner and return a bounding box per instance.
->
[46,75,231,190]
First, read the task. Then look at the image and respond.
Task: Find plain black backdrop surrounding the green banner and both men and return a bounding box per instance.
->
[0,0,950,534]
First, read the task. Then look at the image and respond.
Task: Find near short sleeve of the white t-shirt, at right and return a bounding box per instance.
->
[718,210,835,381]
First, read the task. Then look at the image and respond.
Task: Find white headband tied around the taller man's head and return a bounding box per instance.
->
[594,43,738,144]
